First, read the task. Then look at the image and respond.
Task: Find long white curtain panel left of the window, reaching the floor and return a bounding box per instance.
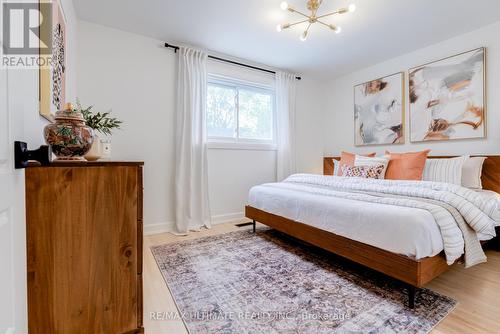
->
[175,47,211,233]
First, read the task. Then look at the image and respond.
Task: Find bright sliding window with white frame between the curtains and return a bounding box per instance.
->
[206,77,275,144]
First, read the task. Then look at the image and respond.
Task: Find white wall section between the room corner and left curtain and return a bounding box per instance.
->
[78,21,176,234]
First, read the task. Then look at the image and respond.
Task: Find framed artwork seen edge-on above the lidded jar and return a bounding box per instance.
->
[39,0,67,121]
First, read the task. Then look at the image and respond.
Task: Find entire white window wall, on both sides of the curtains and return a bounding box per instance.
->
[78,21,323,233]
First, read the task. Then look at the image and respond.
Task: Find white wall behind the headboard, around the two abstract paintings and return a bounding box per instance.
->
[324,22,500,155]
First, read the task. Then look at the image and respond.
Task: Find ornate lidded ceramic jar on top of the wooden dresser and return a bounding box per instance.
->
[44,103,94,161]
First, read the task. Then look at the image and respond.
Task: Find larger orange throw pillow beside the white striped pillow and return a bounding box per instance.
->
[385,150,431,181]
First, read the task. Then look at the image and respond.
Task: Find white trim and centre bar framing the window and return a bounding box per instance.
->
[207,74,277,151]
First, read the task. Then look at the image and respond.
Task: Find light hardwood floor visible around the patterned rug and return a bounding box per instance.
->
[143,220,500,334]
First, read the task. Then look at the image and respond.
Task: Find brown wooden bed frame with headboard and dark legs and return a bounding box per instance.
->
[245,156,500,308]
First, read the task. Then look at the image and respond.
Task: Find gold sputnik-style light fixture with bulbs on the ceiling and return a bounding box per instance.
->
[276,0,356,42]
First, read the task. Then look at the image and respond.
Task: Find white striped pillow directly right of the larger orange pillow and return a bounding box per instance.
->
[424,156,469,186]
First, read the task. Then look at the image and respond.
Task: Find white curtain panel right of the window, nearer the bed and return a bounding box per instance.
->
[276,72,296,181]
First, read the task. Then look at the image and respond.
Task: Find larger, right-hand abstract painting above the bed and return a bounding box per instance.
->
[409,48,486,142]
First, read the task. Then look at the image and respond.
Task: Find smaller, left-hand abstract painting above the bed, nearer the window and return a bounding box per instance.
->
[354,72,405,146]
